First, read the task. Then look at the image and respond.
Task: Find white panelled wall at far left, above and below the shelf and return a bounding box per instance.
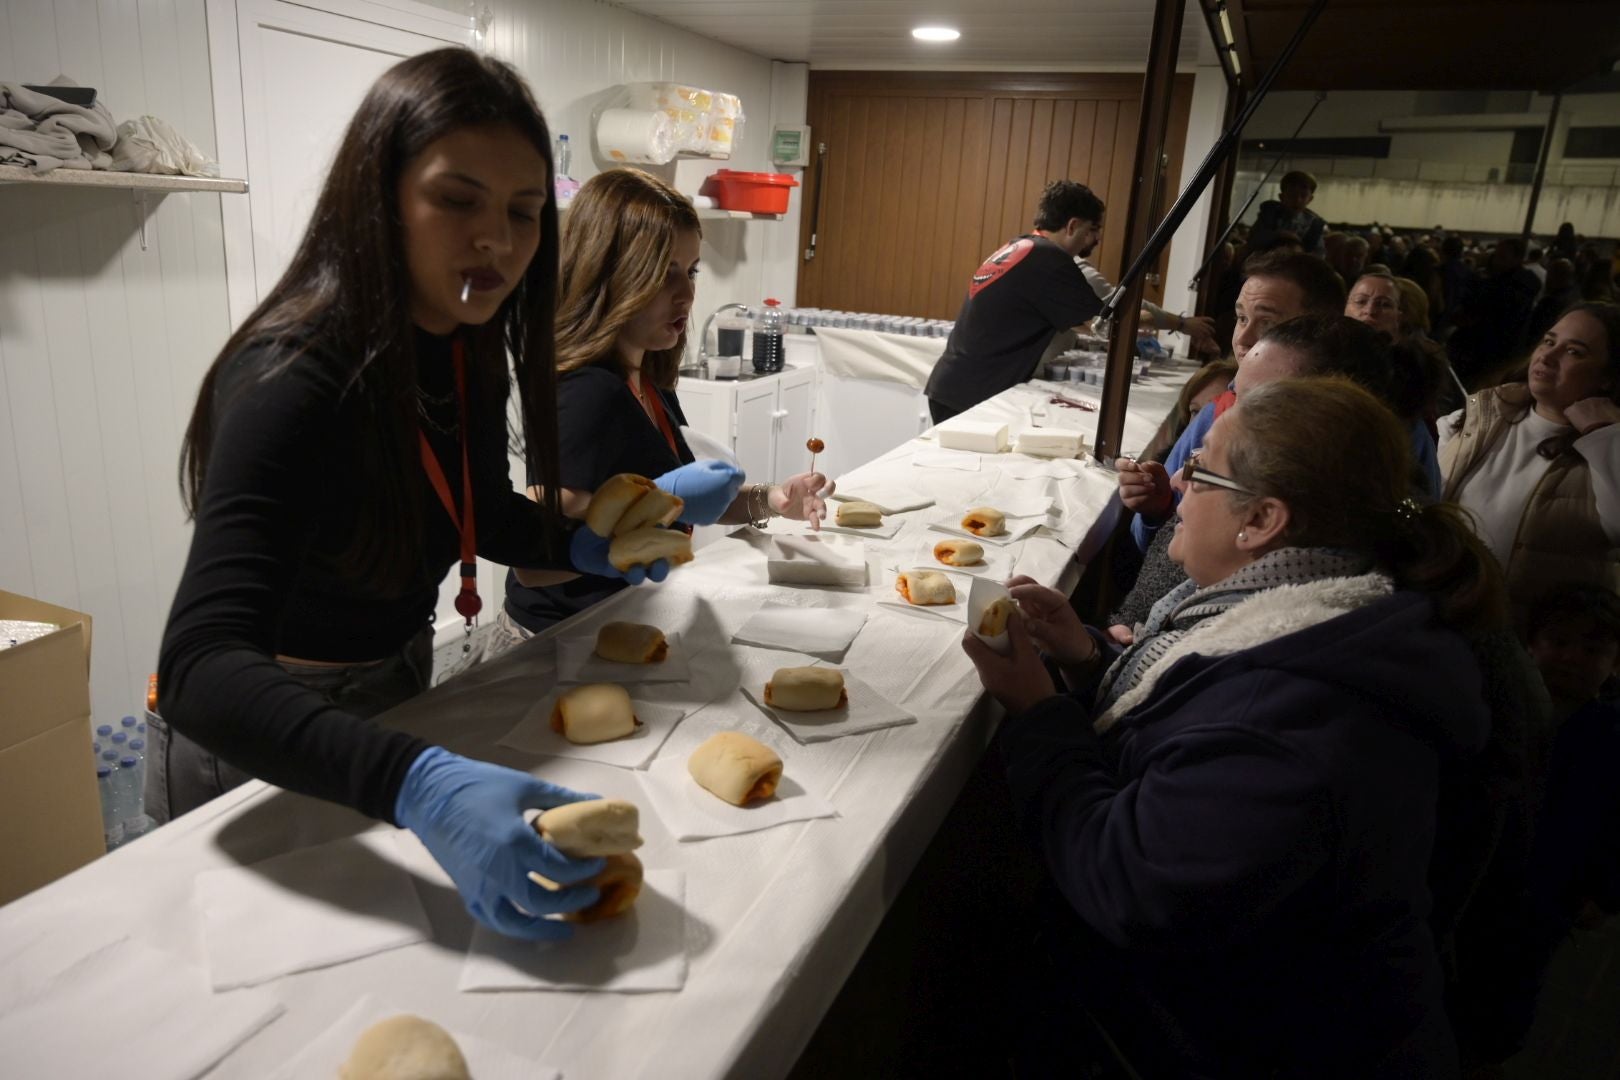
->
[0,0,228,722]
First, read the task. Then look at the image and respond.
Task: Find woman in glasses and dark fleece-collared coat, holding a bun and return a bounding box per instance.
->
[964,379,1505,1077]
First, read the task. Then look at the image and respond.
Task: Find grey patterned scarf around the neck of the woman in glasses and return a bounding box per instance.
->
[1095,547,1372,714]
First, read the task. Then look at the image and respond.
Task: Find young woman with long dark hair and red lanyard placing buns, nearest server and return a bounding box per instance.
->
[147,49,690,938]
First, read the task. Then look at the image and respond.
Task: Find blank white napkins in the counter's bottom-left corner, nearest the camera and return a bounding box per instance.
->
[0,941,282,1080]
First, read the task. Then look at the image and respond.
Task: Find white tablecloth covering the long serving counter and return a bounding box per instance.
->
[0,387,1185,1078]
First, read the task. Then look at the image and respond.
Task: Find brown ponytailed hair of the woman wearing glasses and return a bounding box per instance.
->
[1228,376,1507,636]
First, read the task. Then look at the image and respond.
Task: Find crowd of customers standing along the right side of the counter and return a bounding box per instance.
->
[964,173,1620,1077]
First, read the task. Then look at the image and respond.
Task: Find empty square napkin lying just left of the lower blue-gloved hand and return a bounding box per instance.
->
[194,829,433,989]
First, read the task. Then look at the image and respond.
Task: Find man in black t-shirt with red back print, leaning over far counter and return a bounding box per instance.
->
[923,180,1103,424]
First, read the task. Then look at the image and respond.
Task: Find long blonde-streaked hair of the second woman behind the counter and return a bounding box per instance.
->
[557,168,703,390]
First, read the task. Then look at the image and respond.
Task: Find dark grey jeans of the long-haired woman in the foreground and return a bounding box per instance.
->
[146,628,433,824]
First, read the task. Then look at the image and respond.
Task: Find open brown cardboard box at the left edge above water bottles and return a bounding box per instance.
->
[0,591,107,904]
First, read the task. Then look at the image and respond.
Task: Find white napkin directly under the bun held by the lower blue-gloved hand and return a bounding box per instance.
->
[458,870,687,997]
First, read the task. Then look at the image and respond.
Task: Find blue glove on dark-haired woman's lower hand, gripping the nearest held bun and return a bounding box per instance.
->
[394,746,603,941]
